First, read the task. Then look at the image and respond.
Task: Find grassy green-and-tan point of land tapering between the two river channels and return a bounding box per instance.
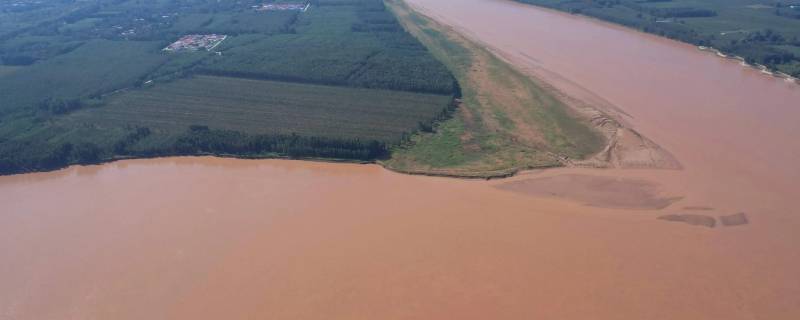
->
[383,0,604,178]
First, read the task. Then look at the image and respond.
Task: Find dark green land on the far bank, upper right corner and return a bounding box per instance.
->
[517,0,800,77]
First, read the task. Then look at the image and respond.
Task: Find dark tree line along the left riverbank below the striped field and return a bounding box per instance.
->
[0,125,389,174]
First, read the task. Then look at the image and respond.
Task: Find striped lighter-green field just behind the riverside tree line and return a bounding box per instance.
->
[67,76,451,143]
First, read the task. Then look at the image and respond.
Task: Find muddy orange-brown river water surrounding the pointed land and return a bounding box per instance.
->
[0,0,800,319]
